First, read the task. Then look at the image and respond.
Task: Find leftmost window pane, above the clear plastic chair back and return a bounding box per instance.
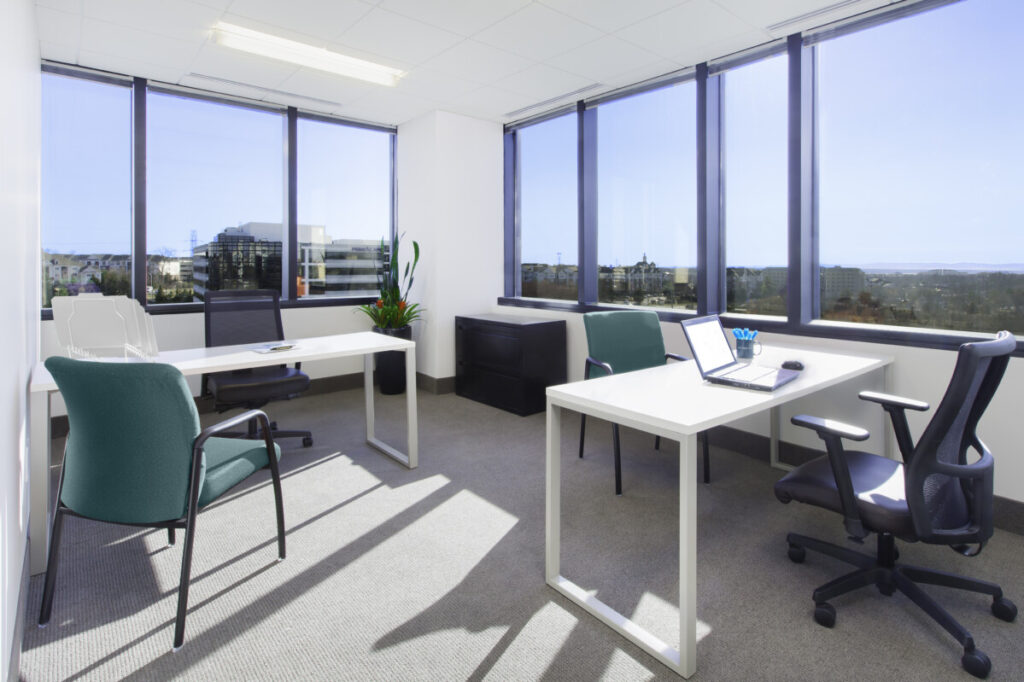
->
[40,74,132,307]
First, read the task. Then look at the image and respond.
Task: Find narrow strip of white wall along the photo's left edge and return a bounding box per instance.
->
[0,0,40,679]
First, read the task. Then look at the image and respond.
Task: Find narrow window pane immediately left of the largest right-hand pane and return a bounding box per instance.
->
[722,55,788,315]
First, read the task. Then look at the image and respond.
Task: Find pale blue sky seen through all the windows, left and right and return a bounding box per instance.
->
[42,0,1024,267]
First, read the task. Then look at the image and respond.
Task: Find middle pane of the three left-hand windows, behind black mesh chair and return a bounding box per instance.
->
[145,92,285,303]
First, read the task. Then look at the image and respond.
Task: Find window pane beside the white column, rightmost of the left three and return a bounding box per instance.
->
[296,119,392,297]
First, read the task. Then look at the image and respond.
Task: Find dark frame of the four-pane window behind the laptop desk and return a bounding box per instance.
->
[498,0,1024,356]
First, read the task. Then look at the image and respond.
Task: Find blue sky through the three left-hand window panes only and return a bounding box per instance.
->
[42,74,391,256]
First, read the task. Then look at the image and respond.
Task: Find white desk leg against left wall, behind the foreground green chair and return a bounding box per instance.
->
[29,391,53,576]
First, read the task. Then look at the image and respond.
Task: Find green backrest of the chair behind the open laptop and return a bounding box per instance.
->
[583,310,665,378]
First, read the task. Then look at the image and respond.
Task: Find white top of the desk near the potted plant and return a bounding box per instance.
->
[30,332,416,392]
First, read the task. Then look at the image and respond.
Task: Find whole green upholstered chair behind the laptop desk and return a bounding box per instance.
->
[580,310,711,495]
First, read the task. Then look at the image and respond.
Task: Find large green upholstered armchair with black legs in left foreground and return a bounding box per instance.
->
[39,357,285,649]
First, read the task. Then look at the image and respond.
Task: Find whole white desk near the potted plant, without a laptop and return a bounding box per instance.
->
[29,332,419,574]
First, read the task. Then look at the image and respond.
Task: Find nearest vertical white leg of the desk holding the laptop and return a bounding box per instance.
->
[678,435,697,677]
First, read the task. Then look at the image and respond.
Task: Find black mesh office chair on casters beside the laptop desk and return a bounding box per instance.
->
[775,332,1017,678]
